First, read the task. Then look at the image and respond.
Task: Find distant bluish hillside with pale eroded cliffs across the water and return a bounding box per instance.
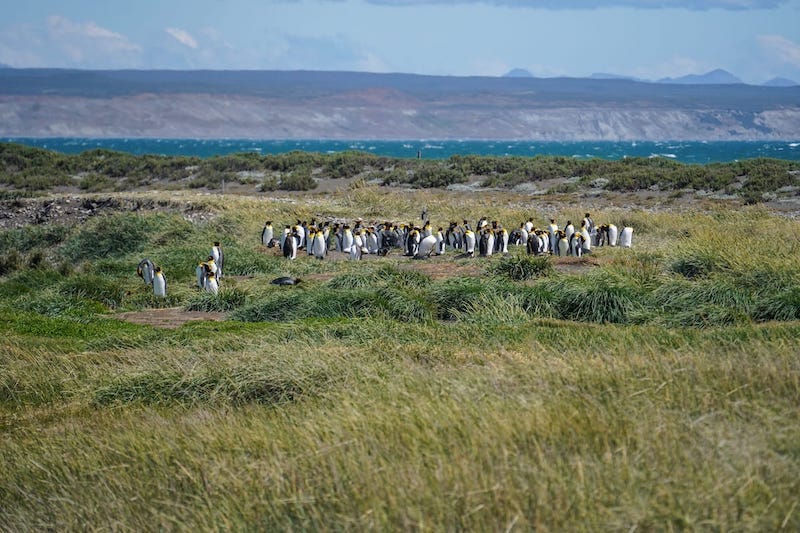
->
[0,69,800,140]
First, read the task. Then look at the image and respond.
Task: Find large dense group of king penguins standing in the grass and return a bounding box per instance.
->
[261,211,633,261]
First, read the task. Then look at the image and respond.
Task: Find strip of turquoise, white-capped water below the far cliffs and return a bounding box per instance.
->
[6,137,800,164]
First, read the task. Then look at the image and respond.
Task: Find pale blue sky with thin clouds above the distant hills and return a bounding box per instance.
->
[0,0,800,83]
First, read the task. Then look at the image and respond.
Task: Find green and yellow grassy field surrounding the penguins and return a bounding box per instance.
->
[0,184,800,531]
